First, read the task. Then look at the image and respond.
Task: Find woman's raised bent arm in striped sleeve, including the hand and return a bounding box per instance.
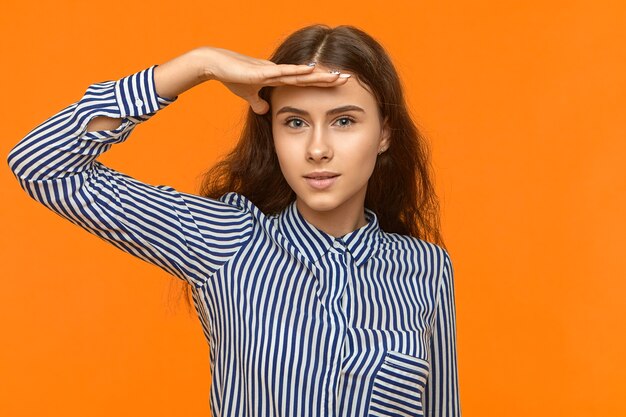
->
[8,47,352,286]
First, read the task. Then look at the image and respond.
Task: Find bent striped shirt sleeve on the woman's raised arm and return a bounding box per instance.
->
[8,65,253,286]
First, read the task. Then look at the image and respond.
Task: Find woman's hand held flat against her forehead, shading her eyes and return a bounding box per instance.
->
[197,47,349,114]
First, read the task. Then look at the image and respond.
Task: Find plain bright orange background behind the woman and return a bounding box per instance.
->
[0,0,626,417]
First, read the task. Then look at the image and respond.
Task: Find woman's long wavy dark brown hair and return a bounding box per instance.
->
[169,25,445,312]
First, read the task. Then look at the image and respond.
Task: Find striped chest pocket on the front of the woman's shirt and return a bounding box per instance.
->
[367,350,430,417]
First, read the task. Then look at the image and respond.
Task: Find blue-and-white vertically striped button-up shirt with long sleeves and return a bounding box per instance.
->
[8,65,461,417]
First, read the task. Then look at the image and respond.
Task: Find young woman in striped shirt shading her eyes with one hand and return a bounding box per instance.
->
[8,25,461,417]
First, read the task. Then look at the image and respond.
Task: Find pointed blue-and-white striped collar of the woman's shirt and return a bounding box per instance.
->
[278,200,381,266]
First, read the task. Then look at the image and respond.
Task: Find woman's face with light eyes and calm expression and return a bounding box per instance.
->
[271,68,389,221]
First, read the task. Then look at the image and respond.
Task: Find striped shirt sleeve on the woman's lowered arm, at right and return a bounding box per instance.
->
[424,250,461,417]
